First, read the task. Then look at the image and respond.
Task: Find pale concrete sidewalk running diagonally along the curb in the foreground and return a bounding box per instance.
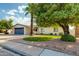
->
[0,41,70,56]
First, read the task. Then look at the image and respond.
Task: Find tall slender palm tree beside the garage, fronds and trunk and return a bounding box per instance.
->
[25,4,35,36]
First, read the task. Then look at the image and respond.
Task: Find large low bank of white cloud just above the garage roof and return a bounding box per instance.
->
[5,16,30,26]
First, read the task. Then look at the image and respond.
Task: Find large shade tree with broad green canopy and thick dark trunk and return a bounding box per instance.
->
[29,3,79,34]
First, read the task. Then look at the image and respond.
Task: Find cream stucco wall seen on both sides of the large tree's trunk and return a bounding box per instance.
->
[35,26,75,36]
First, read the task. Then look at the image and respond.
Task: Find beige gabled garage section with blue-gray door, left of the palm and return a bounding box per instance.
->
[10,24,30,35]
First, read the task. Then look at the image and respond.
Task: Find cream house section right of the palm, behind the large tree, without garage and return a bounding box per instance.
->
[34,27,75,36]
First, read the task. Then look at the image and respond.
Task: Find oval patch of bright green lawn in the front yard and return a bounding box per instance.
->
[23,35,61,42]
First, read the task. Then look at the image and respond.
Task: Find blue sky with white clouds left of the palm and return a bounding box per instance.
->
[0,3,30,25]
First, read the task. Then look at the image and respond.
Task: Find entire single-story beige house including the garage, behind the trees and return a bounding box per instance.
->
[10,24,79,36]
